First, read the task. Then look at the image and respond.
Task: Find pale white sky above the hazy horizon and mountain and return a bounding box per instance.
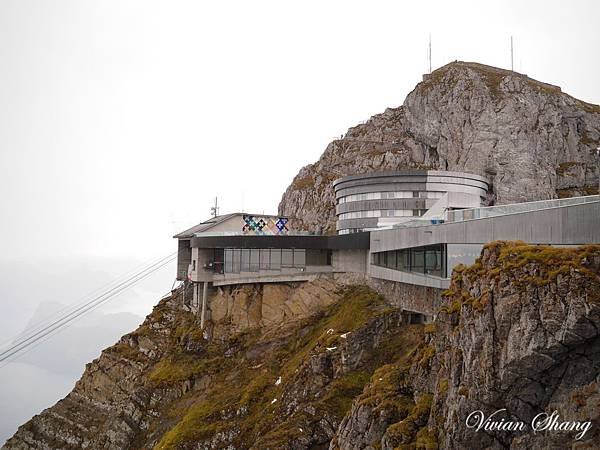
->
[0,0,600,261]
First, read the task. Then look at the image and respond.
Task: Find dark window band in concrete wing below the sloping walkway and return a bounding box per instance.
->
[371,244,447,278]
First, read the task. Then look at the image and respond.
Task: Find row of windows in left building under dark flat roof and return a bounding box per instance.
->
[224,248,306,273]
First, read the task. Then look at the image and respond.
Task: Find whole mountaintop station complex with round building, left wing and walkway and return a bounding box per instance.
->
[174,171,600,324]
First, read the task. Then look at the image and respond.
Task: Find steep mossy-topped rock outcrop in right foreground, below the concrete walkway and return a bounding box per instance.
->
[330,243,600,450]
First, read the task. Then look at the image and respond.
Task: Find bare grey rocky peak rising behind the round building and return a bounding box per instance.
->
[279,62,600,232]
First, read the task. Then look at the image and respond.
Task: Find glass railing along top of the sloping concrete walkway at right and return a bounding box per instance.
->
[446,195,600,222]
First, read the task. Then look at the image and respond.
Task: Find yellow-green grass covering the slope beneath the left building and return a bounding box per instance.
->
[155,286,423,450]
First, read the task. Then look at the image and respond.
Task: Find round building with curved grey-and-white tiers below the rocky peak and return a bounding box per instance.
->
[333,170,489,234]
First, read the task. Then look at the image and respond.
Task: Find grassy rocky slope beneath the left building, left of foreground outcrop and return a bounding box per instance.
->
[3,278,421,450]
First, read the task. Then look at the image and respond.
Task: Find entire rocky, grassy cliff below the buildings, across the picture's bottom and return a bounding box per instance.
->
[3,243,600,450]
